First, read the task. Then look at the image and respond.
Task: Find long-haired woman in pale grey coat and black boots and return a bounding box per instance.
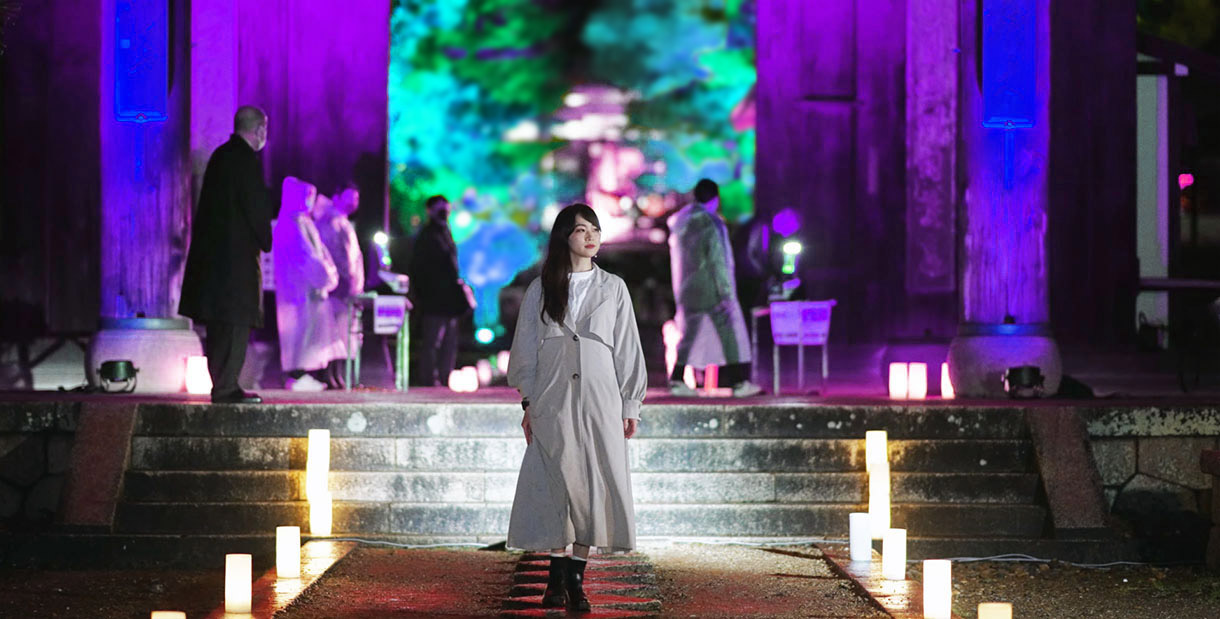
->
[508,204,648,610]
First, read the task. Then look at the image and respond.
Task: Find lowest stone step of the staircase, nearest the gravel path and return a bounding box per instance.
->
[116,502,1046,538]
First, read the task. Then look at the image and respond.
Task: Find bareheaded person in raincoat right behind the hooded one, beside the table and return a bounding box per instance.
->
[314,187,365,388]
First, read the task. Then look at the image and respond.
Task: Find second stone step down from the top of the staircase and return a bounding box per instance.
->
[131,436,1035,472]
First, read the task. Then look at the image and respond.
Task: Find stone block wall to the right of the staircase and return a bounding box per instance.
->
[1087,408,1220,560]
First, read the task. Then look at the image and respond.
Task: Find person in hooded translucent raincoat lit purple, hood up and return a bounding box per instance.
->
[271,176,339,391]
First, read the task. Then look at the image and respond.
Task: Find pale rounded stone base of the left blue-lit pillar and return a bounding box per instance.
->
[85,319,204,393]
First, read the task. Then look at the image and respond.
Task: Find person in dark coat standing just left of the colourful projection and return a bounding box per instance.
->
[407,195,471,386]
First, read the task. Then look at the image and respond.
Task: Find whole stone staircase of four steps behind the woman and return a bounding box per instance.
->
[115,403,1122,560]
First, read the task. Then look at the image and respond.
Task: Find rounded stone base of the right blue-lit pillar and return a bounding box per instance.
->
[949,324,1063,398]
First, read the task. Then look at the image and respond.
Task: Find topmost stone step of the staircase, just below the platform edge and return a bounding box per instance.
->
[135,400,1028,441]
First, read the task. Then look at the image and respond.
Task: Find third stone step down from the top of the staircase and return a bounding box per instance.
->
[123,470,1038,504]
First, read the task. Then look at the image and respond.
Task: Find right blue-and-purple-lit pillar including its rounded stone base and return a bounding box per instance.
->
[949,0,1061,397]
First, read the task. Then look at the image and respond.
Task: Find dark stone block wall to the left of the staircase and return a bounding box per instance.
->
[0,408,77,531]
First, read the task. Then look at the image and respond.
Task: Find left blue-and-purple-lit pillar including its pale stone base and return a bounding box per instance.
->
[85,0,201,392]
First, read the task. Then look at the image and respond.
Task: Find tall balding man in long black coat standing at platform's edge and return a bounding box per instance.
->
[178,105,272,403]
